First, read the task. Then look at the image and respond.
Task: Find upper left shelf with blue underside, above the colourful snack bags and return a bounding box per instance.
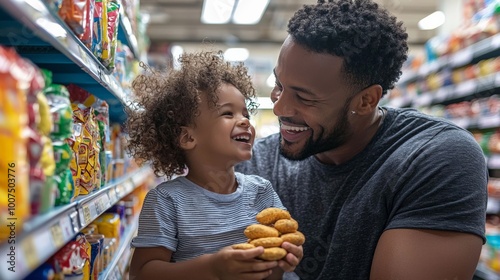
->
[0,0,131,122]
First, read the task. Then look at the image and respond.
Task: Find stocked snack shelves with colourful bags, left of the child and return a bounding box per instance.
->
[0,0,155,279]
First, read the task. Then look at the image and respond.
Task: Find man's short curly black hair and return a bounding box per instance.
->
[288,0,408,95]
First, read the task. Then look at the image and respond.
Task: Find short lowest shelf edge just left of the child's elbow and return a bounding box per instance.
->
[99,216,139,280]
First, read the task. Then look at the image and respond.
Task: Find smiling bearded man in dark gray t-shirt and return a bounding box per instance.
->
[237,0,487,280]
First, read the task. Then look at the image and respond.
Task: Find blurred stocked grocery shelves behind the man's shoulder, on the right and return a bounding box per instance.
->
[385,1,500,279]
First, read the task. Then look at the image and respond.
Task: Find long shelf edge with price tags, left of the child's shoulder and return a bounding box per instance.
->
[0,167,150,280]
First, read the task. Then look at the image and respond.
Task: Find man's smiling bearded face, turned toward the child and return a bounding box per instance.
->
[271,37,353,160]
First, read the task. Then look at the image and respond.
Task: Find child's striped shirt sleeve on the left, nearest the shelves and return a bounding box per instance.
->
[131,188,177,252]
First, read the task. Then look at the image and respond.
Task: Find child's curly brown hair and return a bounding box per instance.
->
[126,51,258,178]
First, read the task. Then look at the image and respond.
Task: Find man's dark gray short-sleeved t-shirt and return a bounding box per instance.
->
[237,108,487,280]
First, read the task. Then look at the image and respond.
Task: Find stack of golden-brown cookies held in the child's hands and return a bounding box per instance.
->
[232,208,305,261]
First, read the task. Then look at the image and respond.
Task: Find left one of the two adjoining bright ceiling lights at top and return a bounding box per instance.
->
[201,0,235,24]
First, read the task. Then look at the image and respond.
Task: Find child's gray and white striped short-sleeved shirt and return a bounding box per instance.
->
[131,172,284,262]
